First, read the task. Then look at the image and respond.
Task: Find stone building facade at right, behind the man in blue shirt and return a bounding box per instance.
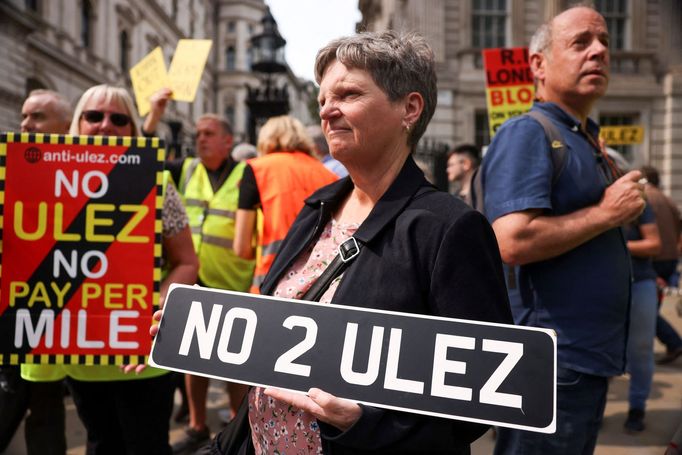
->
[358,0,682,206]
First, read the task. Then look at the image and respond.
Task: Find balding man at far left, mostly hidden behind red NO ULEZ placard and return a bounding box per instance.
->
[0,90,71,455]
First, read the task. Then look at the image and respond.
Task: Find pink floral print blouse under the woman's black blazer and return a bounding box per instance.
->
[249,219,359,455]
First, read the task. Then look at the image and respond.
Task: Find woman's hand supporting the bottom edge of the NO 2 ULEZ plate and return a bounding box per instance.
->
[264,387,362,431]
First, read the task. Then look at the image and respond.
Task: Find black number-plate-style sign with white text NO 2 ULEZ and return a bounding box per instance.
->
[150,285,556,433]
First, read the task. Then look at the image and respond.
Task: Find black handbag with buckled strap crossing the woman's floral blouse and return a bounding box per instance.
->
[207,237,360,455]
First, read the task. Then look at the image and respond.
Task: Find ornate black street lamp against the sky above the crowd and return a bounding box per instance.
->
[246,8,289,144]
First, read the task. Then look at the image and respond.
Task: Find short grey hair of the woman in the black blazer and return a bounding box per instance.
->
[315,30,438,150]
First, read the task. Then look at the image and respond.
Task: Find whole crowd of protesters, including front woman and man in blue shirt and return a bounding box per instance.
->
[0,6,682,455]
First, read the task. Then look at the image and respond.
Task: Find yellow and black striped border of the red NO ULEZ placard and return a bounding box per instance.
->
[0,132,166,365]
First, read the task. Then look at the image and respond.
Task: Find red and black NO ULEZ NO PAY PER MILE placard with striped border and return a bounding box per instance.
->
[0,133,164,364]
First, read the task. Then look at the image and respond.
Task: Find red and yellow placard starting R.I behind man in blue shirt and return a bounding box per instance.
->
[483,47,535,138]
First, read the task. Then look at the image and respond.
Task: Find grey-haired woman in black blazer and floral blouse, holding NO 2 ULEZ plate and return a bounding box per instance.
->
[197,32,512,454]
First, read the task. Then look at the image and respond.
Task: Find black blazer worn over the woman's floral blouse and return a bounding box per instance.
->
[255,157,513,454]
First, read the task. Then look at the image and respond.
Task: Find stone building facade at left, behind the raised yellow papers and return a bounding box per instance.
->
[0,0,312,151]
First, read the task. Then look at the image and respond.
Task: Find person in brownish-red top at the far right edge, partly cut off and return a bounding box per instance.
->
[642,166,682,365]
